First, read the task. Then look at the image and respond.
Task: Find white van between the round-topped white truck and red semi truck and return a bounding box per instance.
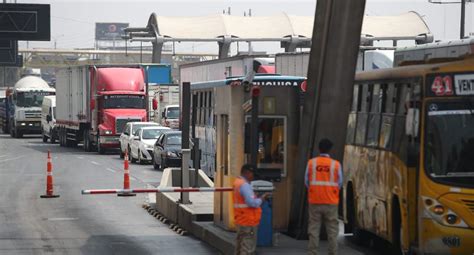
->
[41,96,58,143]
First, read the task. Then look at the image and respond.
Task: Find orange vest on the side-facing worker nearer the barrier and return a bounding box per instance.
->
[233,177,262,227]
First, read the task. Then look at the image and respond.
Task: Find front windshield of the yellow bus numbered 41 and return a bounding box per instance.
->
[425,98,474,185]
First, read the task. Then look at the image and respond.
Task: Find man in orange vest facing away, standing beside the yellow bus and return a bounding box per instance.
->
[305,139,342,255]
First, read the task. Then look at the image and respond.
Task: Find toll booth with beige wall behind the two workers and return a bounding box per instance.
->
[198,74,306,231]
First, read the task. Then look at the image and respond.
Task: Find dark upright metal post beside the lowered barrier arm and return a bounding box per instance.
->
[180,82,191,204]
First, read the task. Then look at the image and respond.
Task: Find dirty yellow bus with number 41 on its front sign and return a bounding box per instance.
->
[341,47,474,254]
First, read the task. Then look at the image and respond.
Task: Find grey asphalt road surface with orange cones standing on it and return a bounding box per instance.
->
[0,134,383,255]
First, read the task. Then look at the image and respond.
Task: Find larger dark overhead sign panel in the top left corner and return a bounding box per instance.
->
[0,4,51,41]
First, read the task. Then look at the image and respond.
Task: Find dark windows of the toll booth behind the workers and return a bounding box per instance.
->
[245,116,286,179]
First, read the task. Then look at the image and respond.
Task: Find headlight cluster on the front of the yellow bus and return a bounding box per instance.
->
[422,196,468,228]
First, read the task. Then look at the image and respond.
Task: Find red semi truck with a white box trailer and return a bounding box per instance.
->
[56,65,148,154]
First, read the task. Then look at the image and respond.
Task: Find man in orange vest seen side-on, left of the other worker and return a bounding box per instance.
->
[233,164,269,255]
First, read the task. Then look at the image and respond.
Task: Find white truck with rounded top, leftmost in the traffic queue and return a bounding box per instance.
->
[0,76,55,138]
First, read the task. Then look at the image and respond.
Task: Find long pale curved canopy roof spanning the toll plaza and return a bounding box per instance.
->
[125,12,433,61]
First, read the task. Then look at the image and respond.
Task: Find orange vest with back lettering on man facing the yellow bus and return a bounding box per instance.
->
[308,157,340,204]
